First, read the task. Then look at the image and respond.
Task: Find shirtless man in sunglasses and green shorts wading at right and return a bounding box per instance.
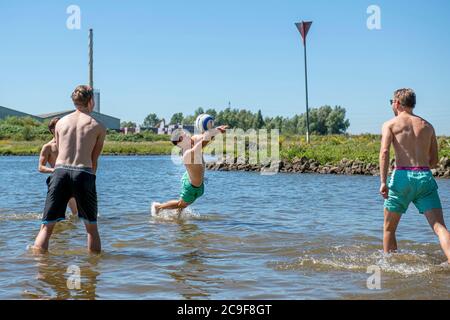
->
[380,89,450,263]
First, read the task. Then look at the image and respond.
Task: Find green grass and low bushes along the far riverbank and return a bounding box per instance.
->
[0,116,450,169]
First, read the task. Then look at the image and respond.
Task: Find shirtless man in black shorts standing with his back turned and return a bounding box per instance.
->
[33,86,106,253]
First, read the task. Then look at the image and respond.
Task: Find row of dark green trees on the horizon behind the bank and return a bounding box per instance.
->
[122,105,350,135]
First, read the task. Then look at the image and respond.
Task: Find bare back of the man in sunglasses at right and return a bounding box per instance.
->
[387,114,435,167]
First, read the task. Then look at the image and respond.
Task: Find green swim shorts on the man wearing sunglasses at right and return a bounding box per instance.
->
[384,170,442,214]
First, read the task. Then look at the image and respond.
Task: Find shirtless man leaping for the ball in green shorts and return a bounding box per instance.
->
[152,126,228,214]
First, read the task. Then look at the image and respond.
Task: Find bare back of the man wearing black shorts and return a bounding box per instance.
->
[56,111,105,168]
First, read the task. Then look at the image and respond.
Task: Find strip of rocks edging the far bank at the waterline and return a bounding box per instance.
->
[206,158,450,179]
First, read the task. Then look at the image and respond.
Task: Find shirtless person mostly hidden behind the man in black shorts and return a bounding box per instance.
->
[38,118,78,216]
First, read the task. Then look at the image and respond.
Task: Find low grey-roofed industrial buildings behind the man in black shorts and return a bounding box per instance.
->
[0,106,120,131]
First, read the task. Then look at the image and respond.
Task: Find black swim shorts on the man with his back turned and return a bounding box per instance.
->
[42,166,97,224]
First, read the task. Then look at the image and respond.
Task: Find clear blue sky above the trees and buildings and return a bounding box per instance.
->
[0,0,450,135]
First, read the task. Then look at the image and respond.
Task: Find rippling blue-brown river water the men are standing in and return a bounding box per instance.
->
[0,157,450,299]
